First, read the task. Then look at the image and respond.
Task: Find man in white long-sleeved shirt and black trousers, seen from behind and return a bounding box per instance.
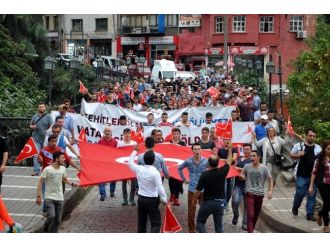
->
[128,145,167,233]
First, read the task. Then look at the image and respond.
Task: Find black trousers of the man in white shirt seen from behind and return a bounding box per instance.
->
[138,195,161,233]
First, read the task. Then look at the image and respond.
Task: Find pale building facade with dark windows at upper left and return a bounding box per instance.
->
[44,14,117,63]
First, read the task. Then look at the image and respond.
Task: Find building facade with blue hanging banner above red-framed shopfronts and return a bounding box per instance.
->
[117,14,201,66]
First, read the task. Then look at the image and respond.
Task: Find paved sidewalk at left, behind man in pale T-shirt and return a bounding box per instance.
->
[1,166,88,232]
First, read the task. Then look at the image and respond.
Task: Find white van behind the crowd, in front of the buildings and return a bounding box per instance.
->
[151,59,178,85]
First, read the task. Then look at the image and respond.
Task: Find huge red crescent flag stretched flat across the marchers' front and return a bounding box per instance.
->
[78,142,240,186]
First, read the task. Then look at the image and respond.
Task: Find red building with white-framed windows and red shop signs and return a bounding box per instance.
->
[176,14,317,84]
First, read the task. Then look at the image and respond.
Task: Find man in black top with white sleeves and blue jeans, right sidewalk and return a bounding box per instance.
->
[290,129,322,221]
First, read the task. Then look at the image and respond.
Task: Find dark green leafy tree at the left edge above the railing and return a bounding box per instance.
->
[0,24,45,116]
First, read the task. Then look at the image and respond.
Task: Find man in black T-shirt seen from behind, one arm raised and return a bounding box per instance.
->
[193,143,232,233]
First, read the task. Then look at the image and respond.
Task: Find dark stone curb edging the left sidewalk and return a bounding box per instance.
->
[28,187,92,233]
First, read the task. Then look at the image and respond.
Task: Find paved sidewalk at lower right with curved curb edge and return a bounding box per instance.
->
[261,172,323,233]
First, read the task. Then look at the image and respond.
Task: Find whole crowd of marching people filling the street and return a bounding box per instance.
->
[0,68,330,232]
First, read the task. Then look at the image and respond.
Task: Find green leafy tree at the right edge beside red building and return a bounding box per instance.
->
[288,16,330,142]
